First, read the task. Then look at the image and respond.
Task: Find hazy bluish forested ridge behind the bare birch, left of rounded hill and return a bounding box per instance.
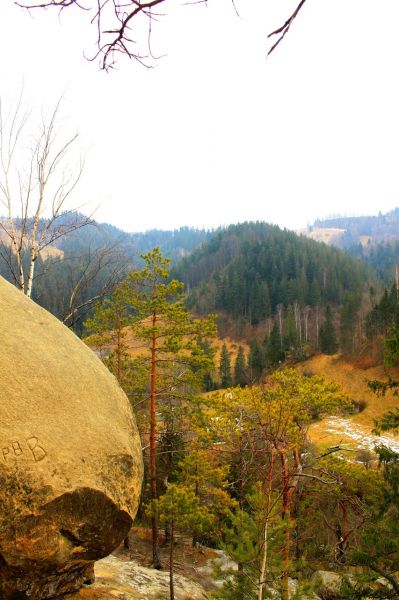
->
[0,212,214,327]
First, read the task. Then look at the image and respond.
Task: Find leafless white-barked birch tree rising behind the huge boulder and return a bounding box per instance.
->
[0,94,92,297]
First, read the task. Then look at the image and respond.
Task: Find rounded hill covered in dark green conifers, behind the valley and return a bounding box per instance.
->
[173,222,370,325]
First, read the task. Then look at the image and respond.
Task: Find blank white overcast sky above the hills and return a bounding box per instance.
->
[0,0,399,231]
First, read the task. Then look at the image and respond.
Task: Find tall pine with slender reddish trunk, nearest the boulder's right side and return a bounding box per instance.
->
[86,248,216,568]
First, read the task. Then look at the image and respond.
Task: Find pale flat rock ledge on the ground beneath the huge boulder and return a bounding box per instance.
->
[65,555,208,600]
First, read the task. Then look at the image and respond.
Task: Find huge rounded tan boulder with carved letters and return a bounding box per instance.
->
[0,277,143,600]
